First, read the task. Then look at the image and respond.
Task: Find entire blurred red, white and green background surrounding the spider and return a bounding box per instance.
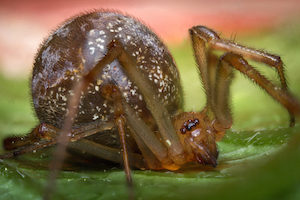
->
[0,0,300,200]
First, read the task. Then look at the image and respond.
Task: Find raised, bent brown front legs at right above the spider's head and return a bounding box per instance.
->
[190,26,300,129]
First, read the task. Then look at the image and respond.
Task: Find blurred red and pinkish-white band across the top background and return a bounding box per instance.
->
[0,0,300,75]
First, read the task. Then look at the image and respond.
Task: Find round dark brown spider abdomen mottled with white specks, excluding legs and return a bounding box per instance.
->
[32,11,181,128]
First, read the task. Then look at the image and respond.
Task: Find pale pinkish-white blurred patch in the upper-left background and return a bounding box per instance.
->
[0,12,47,77]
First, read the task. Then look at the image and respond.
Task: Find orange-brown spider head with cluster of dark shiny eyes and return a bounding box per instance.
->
[175,112,218,167]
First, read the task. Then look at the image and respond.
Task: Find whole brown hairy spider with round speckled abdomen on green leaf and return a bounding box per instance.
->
[0,10,300,200]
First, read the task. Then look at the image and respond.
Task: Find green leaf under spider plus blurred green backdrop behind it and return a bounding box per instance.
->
[0,21,300,199]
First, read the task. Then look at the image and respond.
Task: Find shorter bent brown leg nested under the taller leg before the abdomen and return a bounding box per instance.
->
[101,84,172,170]
